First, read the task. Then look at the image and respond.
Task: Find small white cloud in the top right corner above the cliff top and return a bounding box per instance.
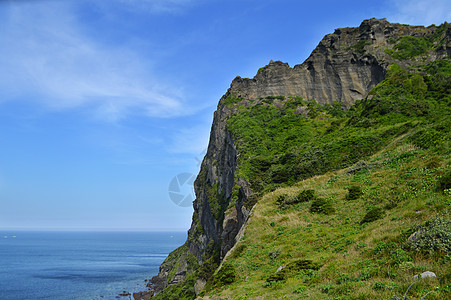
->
[387,0,451,26]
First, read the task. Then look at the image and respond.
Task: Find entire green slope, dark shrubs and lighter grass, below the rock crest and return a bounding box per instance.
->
[202,61,451,299]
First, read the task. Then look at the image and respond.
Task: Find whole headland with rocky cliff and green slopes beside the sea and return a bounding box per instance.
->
[152,19,451,299]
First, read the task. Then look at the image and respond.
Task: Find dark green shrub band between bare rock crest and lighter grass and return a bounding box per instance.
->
[228,60,450,193]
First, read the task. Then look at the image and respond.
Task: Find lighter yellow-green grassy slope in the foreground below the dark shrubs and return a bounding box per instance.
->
[207,145,451,299]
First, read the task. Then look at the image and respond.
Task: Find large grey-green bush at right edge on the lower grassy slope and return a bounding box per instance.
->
[406,218,451,254]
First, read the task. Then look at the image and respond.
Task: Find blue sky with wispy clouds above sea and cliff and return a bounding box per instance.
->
[0,0,451,230]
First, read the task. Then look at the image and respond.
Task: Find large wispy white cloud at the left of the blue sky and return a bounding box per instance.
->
[0,1,189,120]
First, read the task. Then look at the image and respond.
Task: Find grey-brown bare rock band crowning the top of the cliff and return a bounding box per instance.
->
[231,19,451,107]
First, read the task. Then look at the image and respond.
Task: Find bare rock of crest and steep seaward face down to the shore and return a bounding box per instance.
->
[154,19,451,291]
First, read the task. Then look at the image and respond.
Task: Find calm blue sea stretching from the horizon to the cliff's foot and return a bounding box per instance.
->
[0,231,186,300]
